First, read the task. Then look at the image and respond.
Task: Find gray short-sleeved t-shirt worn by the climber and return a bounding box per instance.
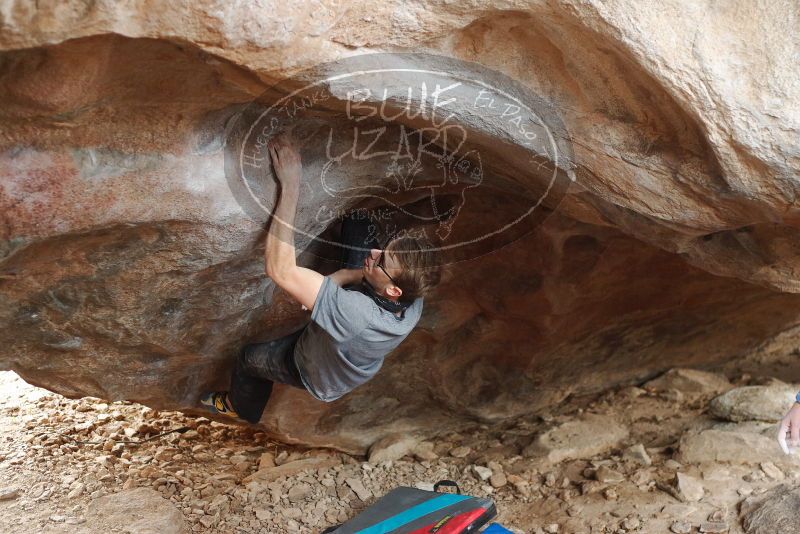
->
[294,276,422,402]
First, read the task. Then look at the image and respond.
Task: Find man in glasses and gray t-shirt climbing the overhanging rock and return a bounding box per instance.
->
[201,136,440,423]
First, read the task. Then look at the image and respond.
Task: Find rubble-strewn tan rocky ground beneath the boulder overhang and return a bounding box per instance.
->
[0,369,800,534]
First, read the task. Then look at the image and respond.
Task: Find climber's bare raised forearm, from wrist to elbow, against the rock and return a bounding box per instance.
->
[264,184,300,281]
